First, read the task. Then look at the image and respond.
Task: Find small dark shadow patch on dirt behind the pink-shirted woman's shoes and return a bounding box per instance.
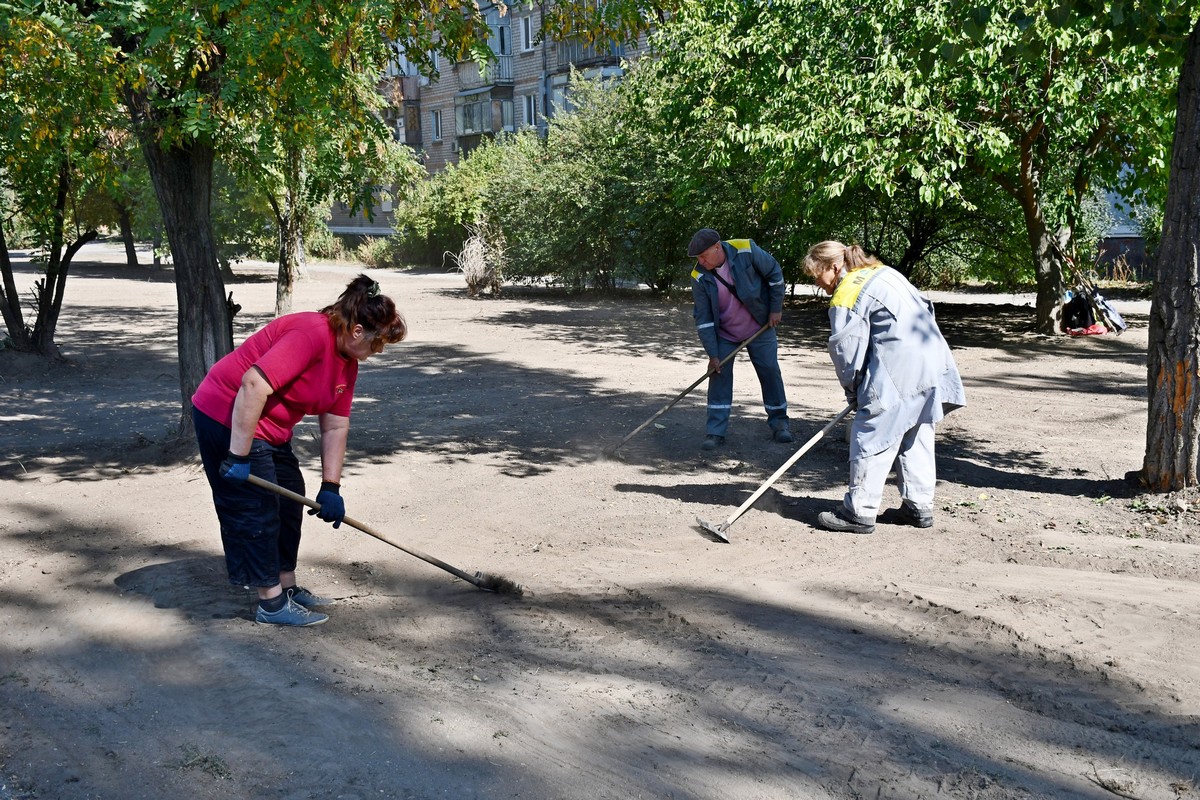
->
[113,555,256,620]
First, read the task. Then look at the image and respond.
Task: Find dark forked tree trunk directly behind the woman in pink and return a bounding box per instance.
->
[142,136,233,437]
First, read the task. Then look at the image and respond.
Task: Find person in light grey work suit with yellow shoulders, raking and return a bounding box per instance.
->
[804,241,966,534]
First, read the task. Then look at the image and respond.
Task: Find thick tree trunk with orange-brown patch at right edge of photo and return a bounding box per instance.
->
[1141,23,1200,492]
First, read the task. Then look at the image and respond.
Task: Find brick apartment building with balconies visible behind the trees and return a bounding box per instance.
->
[329,0,646,236]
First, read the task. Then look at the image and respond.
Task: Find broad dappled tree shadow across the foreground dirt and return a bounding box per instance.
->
[0,509,1200,800]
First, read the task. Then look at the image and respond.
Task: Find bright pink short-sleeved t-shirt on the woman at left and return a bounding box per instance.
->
[192,311,359,445]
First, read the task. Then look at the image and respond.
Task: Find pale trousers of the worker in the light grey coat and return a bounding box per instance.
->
[844,422,937,522]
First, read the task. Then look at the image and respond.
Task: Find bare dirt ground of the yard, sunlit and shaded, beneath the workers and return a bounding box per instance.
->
[0,245,1200,800]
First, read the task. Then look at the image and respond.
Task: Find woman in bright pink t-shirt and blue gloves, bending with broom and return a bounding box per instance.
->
[192,275,408,626]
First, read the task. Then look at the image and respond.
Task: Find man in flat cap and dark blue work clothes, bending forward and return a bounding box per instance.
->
[688,228,794,450]
